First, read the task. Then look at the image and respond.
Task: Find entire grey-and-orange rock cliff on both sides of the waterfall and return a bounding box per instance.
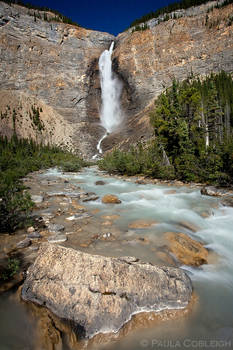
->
[0,2,233,157]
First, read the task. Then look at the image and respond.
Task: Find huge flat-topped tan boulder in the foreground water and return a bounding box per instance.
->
[22,243,192,338]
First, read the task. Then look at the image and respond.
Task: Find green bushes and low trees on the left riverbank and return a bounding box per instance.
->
[0,135,86,232]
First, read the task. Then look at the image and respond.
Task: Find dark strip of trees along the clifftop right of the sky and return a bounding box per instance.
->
[130,0,233,27]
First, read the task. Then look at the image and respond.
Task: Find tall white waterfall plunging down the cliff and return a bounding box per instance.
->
[93,42,122,159]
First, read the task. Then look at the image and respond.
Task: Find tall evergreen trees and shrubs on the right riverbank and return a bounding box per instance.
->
[99,72,233,185]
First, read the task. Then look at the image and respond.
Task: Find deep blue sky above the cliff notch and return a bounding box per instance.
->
[27,0,175,35]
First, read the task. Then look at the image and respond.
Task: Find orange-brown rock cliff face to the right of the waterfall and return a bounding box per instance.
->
[110,3,233,147]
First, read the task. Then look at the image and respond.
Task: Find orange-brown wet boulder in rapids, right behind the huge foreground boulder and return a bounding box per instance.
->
[165,232,208,266]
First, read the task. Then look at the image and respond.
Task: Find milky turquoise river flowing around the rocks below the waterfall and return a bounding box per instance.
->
[0,167,233,350]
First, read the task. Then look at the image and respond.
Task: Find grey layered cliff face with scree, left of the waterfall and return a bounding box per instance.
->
[0,2,114,155]
